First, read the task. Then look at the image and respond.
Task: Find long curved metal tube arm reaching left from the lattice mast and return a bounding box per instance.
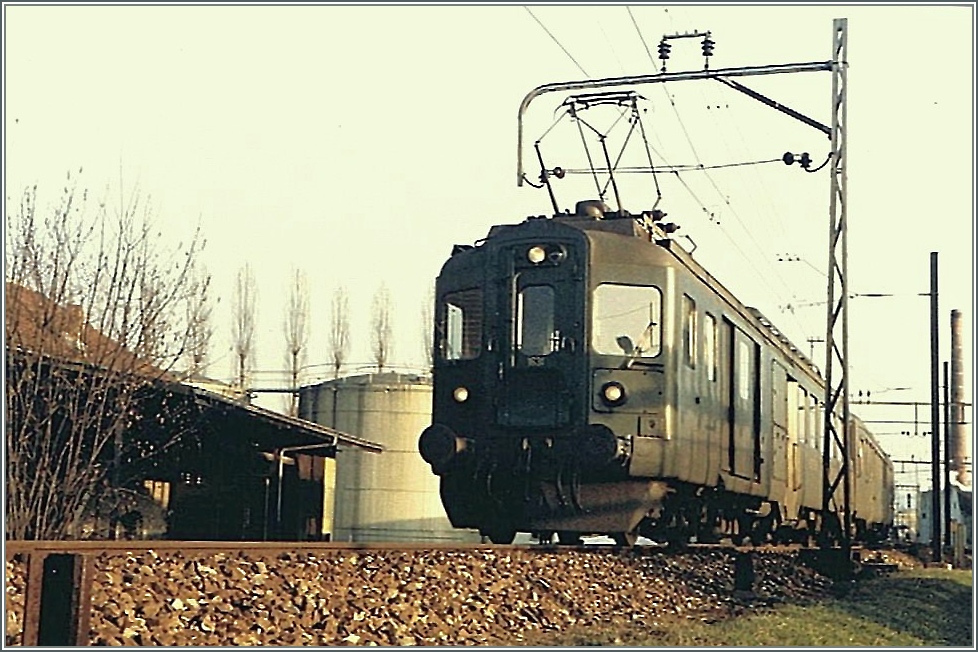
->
[516,61,834,186]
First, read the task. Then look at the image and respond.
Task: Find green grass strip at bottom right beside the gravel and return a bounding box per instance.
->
[526,569,973,648]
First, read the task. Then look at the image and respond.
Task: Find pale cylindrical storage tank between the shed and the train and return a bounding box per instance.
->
[299,373,479,542]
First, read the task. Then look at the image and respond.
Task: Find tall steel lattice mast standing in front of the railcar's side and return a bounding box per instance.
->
[821,18,852,549]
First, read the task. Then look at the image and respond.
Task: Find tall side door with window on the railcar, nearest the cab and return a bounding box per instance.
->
[724,319,761,482]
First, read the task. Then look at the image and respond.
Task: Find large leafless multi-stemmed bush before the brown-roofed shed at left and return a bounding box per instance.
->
[5,169,203,539]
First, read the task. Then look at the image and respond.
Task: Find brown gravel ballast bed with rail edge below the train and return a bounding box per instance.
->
[6,541,912,645]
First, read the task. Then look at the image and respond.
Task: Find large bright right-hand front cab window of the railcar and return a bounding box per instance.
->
[591,283,662,358]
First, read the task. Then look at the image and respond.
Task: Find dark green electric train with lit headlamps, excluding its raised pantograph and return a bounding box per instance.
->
[419,201,893,544]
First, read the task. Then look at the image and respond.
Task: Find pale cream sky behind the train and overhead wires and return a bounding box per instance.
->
[4,3,975,486]
